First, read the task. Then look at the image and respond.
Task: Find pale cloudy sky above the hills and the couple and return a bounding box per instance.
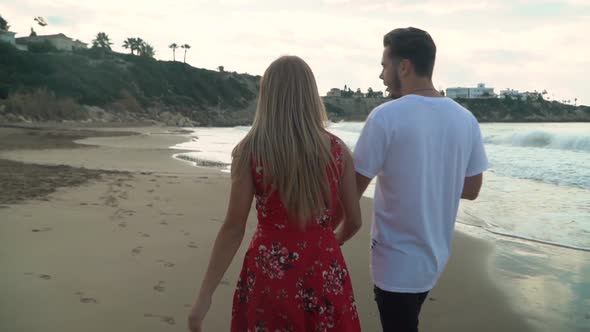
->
[0,0,590,105]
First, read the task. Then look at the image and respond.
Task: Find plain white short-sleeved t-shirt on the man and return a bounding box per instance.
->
[354,95,488,293]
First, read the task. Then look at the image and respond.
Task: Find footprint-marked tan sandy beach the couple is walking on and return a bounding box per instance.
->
[0,127,531,332]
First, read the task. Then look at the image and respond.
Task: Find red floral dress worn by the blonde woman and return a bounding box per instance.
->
[231,135,361,332]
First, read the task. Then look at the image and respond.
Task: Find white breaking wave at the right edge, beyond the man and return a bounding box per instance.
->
[484,130,590,152]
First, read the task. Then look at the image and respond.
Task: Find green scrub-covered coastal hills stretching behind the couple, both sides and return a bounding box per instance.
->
[0,43,590,126]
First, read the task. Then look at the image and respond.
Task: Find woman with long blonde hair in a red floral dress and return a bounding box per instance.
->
[189,56,361,332]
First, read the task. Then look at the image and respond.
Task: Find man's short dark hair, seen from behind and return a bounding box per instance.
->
[383,27,436,78]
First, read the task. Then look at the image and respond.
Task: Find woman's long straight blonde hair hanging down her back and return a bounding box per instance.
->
[233,56,337,224]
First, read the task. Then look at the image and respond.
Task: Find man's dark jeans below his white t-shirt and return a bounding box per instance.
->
[374,286,428,332]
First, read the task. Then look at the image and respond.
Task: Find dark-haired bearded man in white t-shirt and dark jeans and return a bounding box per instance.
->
[354,28,488,332]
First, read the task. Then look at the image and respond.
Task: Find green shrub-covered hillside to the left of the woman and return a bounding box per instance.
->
[0,43,260,125]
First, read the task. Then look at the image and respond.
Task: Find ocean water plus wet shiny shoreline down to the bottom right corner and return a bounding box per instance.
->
[173,122,590,331]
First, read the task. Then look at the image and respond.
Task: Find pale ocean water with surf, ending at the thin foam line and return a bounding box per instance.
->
[173,122,590,251]
